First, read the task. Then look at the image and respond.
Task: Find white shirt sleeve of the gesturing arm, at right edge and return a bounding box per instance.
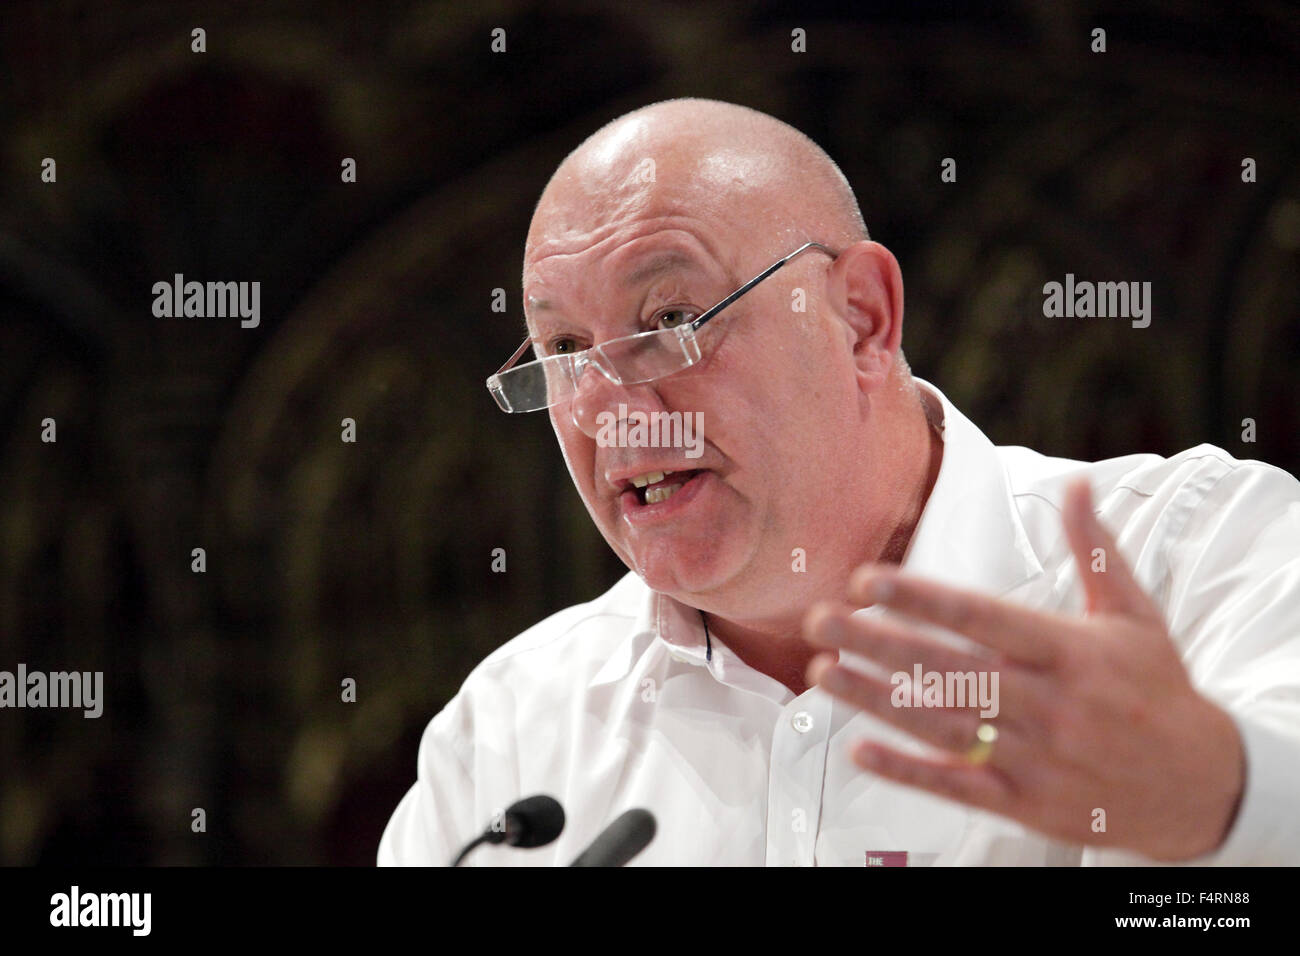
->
[1084,462,1300,866]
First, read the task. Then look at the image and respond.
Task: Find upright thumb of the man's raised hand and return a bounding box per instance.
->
[1062,479,1161,620]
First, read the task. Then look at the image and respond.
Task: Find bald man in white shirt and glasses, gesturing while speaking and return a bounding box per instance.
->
[378,100,1300,866]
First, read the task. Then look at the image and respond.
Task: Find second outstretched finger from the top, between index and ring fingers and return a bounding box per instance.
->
[803,605,1050,723]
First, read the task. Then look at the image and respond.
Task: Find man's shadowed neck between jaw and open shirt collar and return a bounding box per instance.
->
[701,382,944,696]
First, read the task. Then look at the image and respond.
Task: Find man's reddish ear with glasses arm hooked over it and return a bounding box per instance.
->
[829,239,902,392]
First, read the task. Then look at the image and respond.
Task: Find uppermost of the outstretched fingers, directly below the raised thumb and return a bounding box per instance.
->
[849,564,1071,667]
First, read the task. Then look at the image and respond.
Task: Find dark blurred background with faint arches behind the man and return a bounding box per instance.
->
[0,0,1300,864]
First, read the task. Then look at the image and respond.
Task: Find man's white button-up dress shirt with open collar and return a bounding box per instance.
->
[378,380,1300,866]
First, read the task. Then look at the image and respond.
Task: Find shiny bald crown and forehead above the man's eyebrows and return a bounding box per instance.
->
[525,99,868,269]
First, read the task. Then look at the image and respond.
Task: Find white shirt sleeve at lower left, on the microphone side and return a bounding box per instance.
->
[378,695,484,866]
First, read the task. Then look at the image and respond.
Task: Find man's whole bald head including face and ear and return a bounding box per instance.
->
[523,99,932,621]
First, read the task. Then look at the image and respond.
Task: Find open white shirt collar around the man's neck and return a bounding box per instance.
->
[590,377,1043,687]
